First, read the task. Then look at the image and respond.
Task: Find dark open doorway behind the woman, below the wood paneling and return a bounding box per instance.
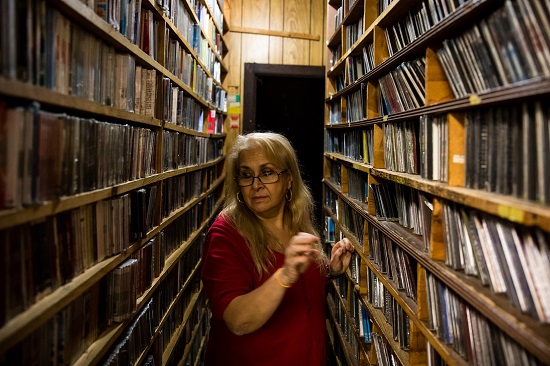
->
[243,64,325,232]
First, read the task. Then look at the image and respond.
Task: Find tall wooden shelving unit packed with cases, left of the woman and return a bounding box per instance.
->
[0,0,228,365]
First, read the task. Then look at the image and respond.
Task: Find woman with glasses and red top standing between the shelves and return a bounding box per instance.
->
[201,132,353,366]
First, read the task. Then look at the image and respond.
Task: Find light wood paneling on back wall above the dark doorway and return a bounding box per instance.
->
[226,0,326,132]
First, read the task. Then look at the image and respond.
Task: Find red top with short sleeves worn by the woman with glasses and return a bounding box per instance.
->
[201,217,327,366]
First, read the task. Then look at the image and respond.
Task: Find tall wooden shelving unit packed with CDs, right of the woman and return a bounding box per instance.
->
[323,0,550,365]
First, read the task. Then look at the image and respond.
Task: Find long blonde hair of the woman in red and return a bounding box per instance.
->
[221,132,328,276]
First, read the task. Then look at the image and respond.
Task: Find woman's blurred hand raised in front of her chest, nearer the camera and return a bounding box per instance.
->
[280,232,320,285]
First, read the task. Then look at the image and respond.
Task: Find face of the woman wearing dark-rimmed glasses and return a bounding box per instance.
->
[238,150,291,218]
